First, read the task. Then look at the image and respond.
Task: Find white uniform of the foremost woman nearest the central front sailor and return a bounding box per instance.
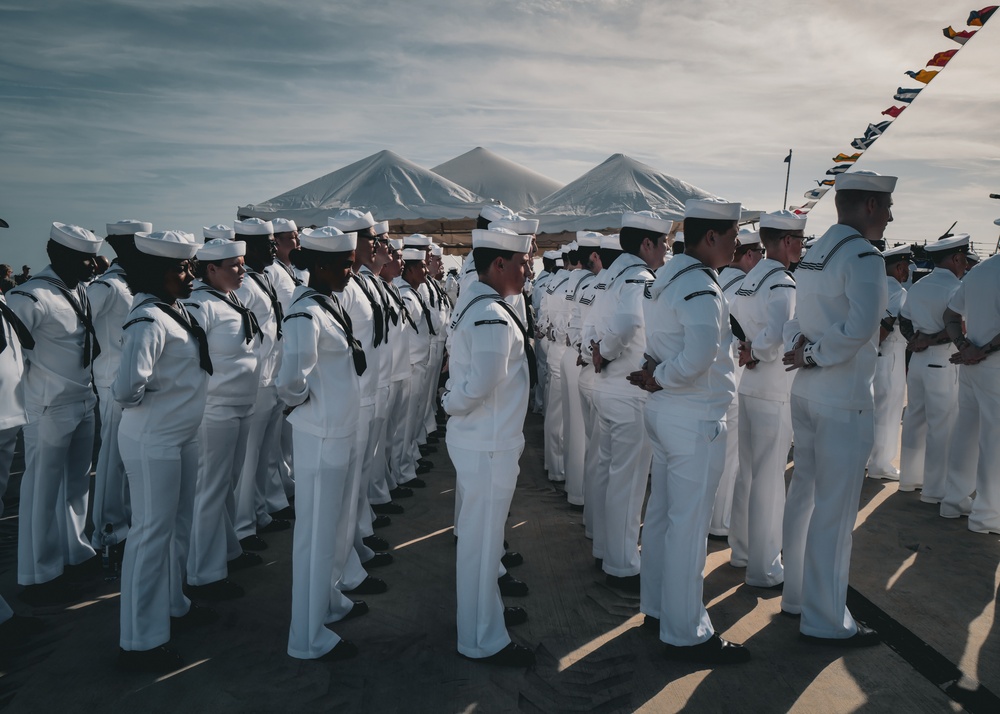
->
[277,280,371,659]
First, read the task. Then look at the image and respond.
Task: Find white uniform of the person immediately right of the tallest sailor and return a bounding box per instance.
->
[868,268,906,481]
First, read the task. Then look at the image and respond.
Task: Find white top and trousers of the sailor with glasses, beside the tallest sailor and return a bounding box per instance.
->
[729,259,795,587]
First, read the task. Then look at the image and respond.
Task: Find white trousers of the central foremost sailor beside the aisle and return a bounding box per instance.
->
[448,444,521,657]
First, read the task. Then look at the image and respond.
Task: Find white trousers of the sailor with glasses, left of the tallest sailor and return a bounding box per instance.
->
[729,394,792,587]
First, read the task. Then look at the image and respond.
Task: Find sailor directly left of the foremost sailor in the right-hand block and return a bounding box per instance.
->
[590,211,673,593]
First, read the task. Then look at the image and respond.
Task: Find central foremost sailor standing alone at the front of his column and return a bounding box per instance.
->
[442,229,535,667]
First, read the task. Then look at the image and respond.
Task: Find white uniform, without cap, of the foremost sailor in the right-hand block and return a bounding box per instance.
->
[640,254,736,647]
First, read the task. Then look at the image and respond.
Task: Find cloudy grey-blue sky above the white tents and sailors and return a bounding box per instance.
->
[0,0,1000,269]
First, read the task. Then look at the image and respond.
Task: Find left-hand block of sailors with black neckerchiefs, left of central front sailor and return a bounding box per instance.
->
[0,211,450,670]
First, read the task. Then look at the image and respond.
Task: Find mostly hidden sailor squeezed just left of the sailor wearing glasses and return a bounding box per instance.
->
[708,229,763,540]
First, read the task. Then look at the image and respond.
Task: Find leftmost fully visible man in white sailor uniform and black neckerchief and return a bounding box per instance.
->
[6,223,103,604]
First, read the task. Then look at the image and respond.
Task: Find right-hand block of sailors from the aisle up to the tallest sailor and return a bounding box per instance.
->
[533,172,996,663]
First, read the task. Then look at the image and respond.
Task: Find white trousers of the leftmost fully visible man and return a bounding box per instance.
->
[17,399,95,585]
